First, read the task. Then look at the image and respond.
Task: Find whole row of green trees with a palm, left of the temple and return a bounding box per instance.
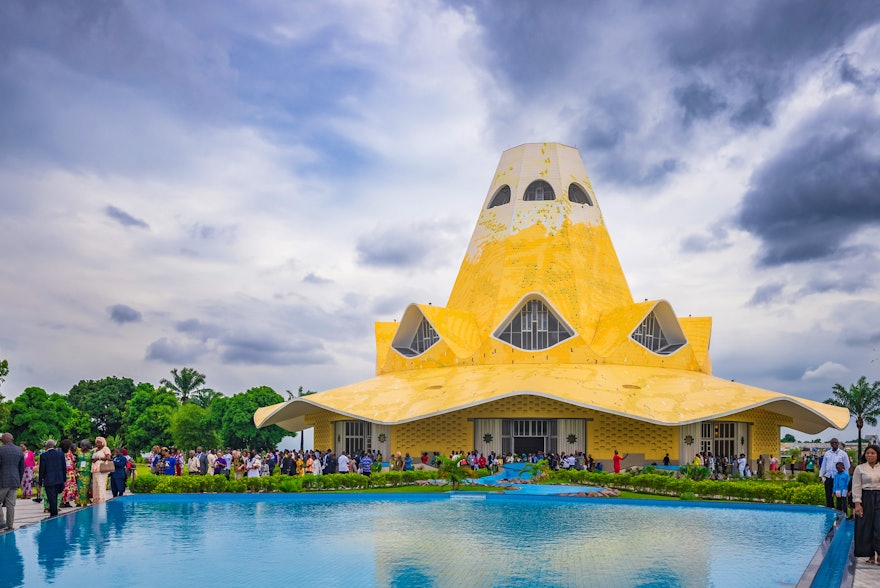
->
[0,360,292,454]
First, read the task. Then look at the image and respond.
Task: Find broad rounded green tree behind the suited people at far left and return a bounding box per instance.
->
[8,387,92,447]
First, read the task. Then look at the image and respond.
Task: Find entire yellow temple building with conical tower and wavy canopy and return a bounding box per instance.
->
[254,143,850,466]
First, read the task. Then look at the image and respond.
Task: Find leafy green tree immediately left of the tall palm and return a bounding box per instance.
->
[120,383,178,453]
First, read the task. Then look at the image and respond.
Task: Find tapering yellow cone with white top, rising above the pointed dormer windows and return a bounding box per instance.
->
[447,143,633,340]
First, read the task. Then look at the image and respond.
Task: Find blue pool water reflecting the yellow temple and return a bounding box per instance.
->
[0,494,835,588]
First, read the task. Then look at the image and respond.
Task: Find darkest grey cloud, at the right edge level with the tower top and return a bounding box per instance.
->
[737,103,880,266]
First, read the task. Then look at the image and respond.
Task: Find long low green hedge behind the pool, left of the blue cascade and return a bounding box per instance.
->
[131,470,437,494]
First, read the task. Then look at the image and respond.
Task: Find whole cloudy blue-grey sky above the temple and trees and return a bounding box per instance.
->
[0,0,880,438]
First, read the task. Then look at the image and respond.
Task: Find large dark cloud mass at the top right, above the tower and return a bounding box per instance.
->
[470,0,880,186]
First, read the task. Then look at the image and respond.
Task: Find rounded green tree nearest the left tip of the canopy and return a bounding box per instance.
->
[220,386,287,451]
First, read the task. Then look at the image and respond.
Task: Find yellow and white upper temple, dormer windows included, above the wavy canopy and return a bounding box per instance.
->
[376,143,711,374]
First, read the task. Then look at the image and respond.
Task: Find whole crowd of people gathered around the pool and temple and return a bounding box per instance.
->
[0,433,880,564]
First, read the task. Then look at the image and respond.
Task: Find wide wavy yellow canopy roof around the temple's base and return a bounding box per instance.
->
[254,364,850,434]
